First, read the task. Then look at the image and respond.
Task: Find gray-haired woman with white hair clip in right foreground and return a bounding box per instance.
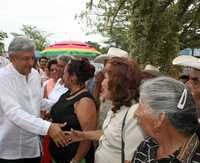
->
[132,77,200,163]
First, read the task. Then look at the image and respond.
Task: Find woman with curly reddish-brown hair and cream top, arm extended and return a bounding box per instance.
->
[65,57,143,163]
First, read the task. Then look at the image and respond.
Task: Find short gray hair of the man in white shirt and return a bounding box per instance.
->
[8,37,35,56]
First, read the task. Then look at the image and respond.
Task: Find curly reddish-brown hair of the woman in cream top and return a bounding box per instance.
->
[105,57,141,112]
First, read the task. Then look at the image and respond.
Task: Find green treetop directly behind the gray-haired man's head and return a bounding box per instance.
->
[11,25,49,51]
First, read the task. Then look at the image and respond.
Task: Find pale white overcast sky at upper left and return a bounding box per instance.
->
[0,0,102,47]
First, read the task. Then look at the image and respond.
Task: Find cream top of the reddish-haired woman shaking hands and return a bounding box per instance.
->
[95,105,143,163]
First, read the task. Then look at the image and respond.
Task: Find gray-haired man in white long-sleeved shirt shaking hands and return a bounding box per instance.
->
[0,37,66,163]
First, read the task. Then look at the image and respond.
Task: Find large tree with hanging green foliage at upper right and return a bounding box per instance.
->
[81,0,200,72]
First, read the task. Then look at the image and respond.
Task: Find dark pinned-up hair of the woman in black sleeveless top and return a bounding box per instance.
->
[67,59,95,85]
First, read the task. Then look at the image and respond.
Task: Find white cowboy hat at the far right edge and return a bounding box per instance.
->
[172,55,200,70]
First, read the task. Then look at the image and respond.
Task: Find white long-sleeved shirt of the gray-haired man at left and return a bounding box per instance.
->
[0,64,52,159]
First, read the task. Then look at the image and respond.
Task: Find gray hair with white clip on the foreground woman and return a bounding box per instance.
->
[140,77,199,135]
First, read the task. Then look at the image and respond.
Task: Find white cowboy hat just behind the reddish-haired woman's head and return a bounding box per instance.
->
[94,47,128,64]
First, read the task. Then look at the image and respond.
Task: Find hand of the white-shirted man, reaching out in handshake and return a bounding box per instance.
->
[48,123,69,147]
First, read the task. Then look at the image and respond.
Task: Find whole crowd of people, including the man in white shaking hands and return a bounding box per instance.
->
[0,37,200,163]
